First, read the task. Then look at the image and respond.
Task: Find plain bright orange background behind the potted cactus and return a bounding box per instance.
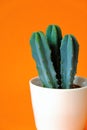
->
[0,0,87,130]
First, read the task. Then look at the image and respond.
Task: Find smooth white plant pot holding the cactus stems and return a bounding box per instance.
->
[29,77,87,130]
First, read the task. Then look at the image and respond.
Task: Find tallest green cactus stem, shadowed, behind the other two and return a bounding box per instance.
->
[46,25,62,86]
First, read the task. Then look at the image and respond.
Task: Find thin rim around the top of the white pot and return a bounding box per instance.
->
[29,75,87,91]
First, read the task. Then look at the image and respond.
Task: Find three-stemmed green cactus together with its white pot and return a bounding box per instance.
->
[29,25,87,130]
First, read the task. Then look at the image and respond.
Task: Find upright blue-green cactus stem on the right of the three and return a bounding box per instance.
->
[60,35,79,88]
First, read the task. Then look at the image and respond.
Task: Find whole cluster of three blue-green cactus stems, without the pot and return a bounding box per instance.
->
[30,25,79,89]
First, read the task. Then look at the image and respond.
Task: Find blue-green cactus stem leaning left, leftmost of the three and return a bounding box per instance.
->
[30,32,58,88]
